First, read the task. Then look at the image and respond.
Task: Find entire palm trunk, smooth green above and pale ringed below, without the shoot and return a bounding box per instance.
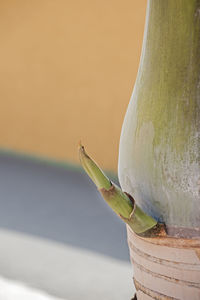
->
[119,0,200,300]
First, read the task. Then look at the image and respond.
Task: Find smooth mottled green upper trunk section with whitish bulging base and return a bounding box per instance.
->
[119,0,200,233]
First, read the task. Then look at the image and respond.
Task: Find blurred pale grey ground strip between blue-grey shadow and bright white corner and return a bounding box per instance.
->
[0,230,134,300]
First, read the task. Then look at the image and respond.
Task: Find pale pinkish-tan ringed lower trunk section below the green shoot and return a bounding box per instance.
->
[127,227,200,300]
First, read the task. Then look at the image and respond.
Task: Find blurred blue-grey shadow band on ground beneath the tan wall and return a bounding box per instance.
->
[0,154,129,261]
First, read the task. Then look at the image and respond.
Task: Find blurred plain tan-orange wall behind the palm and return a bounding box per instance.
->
[0,0,146,171]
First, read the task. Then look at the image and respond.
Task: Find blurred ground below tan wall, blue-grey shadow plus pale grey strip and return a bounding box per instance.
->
[0,154,133,300]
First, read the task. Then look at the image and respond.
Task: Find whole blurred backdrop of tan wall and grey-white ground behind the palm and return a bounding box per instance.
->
[0,0,147,300]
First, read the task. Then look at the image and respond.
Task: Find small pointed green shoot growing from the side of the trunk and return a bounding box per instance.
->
[79,144,162,235]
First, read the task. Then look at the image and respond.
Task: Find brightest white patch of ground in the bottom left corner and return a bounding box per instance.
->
[0,277,61,300]
